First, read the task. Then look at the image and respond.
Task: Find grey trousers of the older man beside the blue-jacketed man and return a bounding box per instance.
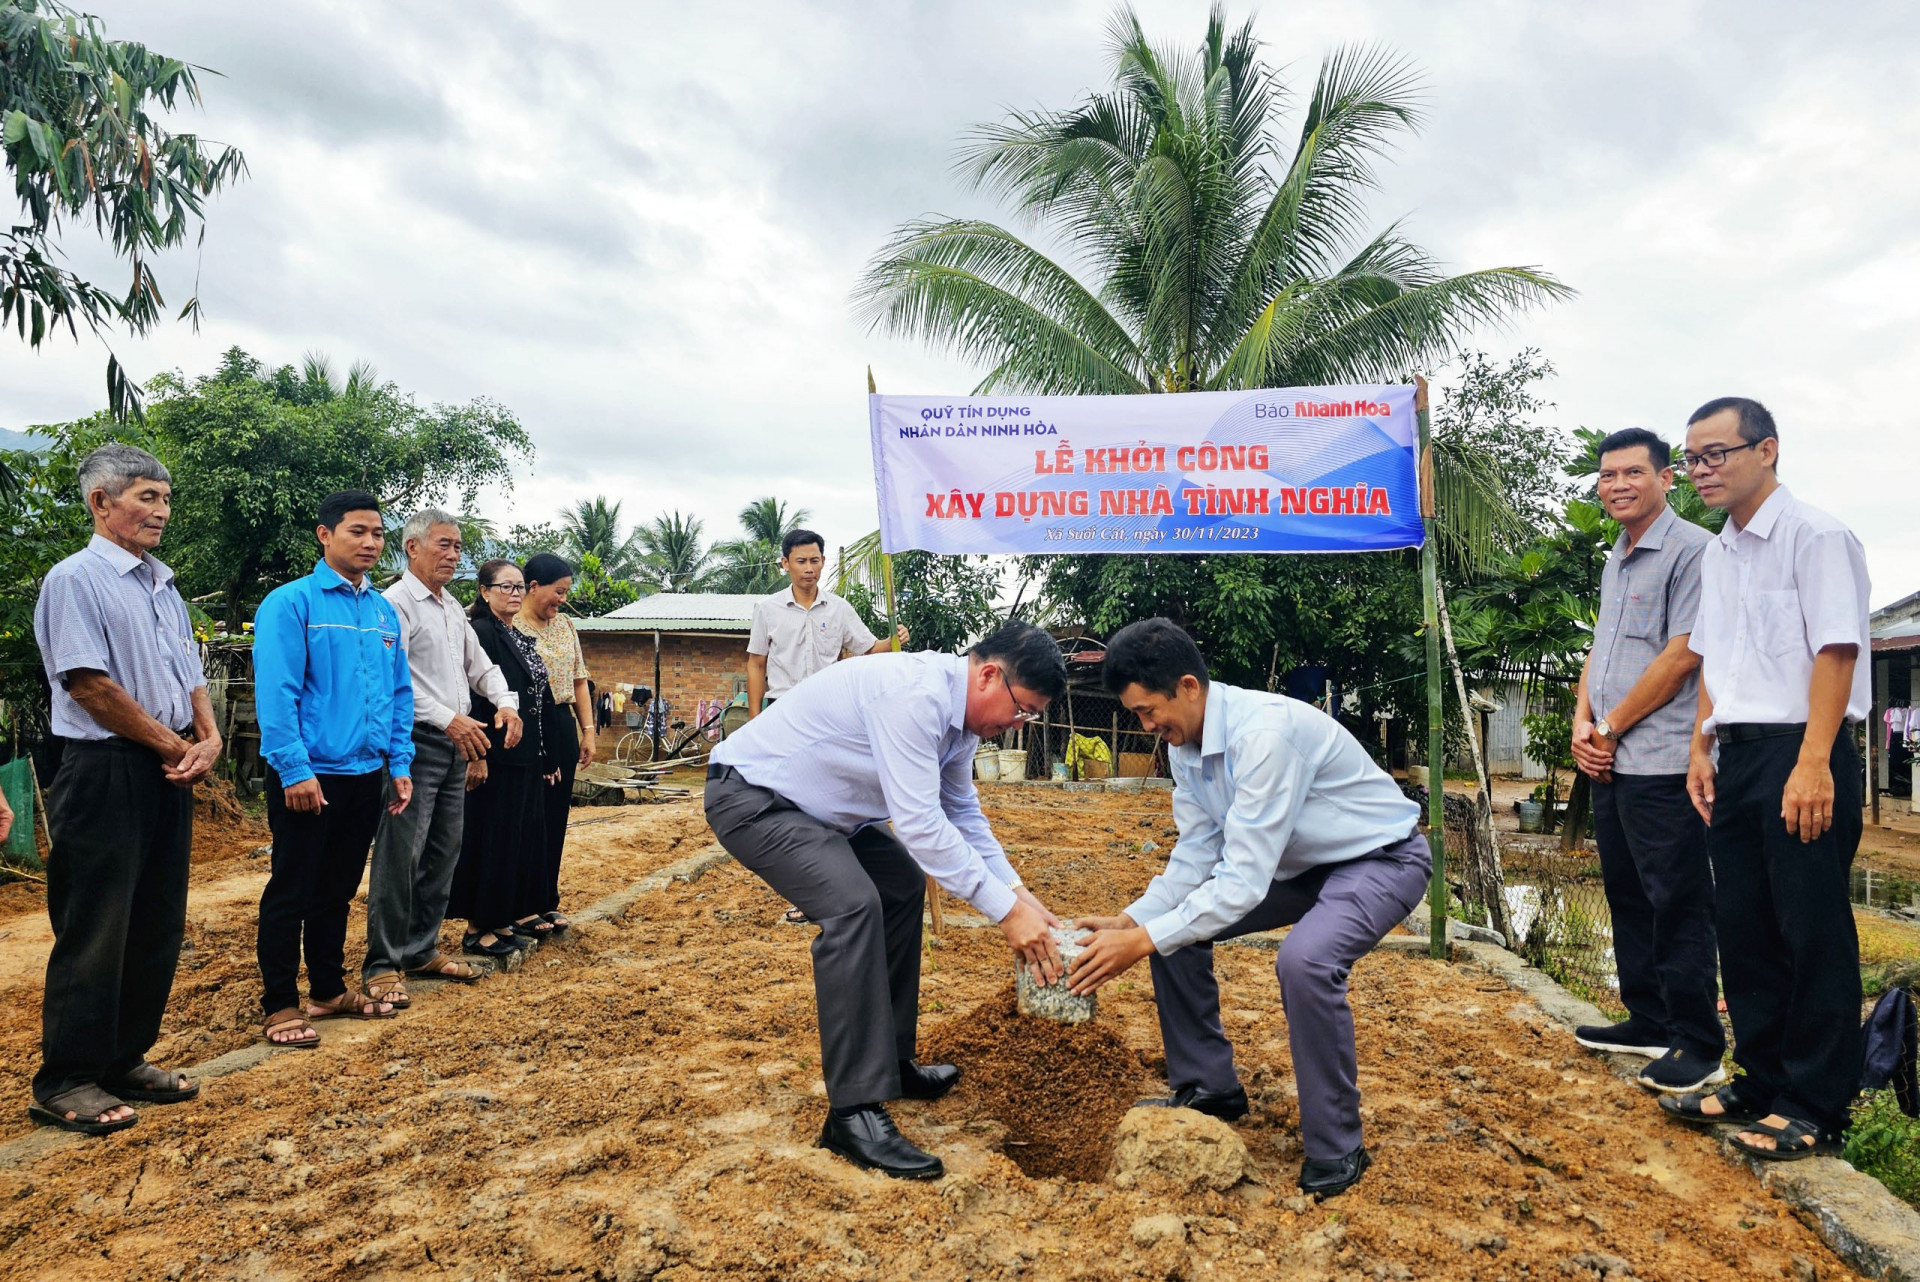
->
[361,724,467,979]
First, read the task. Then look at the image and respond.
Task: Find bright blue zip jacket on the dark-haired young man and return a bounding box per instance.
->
[253,560,413,787]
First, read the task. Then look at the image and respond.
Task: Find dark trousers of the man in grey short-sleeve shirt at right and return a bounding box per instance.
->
[1594,773,1726,1059]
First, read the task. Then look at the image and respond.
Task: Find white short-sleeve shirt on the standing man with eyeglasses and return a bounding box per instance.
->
[1688,486,1872,735]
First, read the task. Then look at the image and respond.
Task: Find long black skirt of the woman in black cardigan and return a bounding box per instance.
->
[447,756,547,931]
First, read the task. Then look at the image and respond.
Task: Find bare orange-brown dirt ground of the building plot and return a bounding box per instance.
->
[0,785,1849,1282]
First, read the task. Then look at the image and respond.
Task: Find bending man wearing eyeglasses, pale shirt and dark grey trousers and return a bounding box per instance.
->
[707,622,1068,1180]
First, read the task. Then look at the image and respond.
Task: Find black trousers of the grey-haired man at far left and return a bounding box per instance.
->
[33,739,194,1100]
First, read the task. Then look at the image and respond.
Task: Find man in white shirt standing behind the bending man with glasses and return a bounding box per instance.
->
[747,530,908,716]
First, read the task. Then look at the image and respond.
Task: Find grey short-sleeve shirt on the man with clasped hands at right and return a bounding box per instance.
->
[1586,509,1713,775]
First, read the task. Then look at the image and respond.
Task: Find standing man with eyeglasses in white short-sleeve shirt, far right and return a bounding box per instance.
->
[1661,397,1870,1159]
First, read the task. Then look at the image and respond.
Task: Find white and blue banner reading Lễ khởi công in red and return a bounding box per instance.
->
[868,384,1423,553]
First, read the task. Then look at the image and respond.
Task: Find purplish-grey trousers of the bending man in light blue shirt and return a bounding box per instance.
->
[1150,835,1430,1161]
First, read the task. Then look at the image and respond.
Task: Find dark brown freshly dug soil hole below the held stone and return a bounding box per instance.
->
[922,986,1152,1180]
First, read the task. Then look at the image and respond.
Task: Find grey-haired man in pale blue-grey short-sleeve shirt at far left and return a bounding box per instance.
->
[27,443,221,1134]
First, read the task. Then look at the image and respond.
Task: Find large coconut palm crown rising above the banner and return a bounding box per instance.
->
[854,6,1571,395]
